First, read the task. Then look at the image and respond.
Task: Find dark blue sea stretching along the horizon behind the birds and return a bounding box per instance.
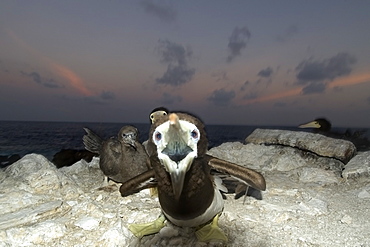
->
[0,121,370,160]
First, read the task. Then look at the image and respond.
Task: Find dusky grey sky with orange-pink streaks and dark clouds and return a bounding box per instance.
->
[0,0,370,128]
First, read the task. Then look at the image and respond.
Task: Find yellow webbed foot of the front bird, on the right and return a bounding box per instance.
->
[195,214,227,242]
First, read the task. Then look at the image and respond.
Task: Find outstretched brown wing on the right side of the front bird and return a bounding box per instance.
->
[205,155,266,190]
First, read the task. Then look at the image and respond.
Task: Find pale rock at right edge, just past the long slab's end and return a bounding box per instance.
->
[342,151,370,179]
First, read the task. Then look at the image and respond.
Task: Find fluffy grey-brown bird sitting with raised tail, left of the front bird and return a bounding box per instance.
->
[83,125,150,183]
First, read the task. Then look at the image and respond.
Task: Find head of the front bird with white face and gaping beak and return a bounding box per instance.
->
[149,113,208,198]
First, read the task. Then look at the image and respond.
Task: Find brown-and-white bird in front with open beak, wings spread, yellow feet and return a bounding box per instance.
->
[120,113,266,241]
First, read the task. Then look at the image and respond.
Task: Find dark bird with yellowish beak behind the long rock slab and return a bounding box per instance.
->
[298,118,370,151]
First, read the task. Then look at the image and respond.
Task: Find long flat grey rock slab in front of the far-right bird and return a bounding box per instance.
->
[245,129,356,163]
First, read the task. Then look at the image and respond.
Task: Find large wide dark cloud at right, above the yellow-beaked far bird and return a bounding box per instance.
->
[295,52,356,94]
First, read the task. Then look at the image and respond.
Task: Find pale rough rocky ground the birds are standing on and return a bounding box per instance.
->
[0,130,370,247]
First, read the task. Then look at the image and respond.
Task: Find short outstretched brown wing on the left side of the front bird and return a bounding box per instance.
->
[119,169,157,196]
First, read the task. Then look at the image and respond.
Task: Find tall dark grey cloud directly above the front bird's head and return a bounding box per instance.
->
[156,40,195,86]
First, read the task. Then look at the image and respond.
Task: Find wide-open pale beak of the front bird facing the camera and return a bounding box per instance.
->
[158,113,197,199]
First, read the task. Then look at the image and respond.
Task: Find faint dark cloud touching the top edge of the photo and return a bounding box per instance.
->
[140,1,177,22]
